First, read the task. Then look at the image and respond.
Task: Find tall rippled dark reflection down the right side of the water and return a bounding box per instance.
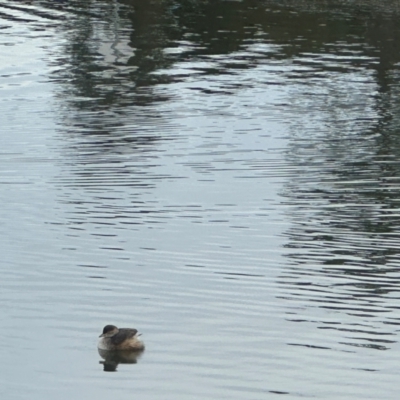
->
[280,47,400,350]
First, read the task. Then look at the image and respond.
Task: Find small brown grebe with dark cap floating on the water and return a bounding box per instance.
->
[97,325,144,350]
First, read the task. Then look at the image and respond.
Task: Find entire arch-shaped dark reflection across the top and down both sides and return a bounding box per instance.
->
[4,0,400,349]
